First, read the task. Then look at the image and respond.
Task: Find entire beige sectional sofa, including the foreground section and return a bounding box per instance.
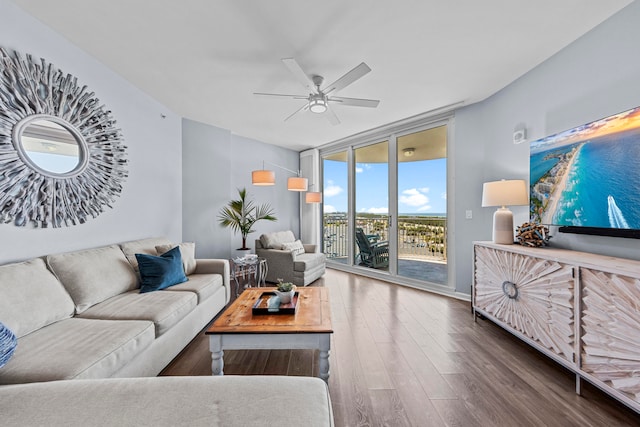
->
[0,238,334,427]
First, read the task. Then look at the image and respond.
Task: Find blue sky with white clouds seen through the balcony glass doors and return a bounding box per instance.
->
[323,159,447,214]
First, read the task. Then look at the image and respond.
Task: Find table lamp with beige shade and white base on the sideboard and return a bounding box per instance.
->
[482,179,529,245]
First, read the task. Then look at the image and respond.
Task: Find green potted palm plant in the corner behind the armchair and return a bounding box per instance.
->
[218,188,277,251]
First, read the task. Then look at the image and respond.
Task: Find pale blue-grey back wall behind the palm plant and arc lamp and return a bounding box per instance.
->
[182,119,304,258]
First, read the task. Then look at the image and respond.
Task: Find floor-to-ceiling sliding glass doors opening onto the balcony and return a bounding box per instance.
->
[321,120,450,286]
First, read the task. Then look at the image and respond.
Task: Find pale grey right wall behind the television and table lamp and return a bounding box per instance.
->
[455,2,640,293]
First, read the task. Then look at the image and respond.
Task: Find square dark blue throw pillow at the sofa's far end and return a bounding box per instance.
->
[136,246,189,293]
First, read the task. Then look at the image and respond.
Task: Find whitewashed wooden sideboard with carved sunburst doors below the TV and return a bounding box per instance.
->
[473,242,640,412]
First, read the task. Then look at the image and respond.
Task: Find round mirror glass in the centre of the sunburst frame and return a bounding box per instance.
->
[18,118,82,176]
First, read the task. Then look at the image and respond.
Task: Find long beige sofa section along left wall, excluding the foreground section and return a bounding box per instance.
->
[0,238,231,384]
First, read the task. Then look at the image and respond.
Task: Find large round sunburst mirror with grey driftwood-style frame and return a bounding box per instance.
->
[0,48,127,228]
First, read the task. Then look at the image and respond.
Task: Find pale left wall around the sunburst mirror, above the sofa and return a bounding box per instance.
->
[0,0,182,263]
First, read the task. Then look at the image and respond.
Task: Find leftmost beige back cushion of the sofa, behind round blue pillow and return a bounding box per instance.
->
[0,258,74,338]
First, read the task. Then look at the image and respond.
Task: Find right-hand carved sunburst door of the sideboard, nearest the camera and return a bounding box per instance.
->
[580,268,640,402]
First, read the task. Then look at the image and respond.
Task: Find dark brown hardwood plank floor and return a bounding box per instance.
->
[161,270,640,427]
